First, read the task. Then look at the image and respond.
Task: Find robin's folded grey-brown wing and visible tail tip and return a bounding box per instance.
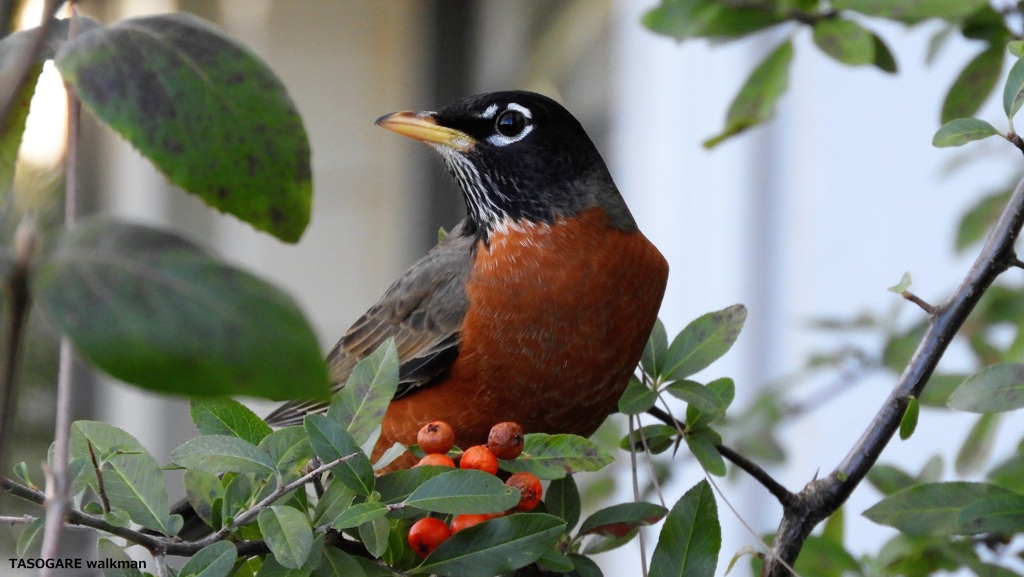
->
[266,222,476,426]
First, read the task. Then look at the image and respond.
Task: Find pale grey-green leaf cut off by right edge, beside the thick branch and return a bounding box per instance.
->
[947,363,1024,413]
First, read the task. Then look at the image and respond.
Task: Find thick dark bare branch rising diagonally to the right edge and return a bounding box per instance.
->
[762,180,1024,577]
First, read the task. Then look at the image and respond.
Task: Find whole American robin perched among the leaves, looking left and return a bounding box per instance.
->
[267,91,669,466]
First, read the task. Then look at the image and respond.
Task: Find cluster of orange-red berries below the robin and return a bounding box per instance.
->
[409,421,544,558]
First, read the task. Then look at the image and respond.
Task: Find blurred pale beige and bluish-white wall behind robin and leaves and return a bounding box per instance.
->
[0,0,1024,575]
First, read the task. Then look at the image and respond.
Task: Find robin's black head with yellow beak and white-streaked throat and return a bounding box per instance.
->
[377,91,635,238]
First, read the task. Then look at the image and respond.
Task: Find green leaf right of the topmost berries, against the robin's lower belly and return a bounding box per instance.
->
[500,432,614,481]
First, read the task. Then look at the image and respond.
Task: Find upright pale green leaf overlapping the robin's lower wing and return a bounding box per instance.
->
[327,338,398,446]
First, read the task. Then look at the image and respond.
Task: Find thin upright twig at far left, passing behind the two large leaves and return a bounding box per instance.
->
[40,0,81,577]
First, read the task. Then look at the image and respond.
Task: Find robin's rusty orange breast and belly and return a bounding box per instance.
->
[378,208,669,465]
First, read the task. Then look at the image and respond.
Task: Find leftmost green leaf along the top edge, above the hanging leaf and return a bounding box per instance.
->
[643,0,785,40]
